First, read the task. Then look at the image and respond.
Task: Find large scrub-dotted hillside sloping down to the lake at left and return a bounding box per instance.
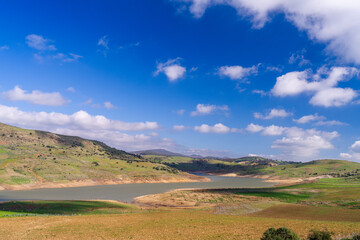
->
[0,123,204,189]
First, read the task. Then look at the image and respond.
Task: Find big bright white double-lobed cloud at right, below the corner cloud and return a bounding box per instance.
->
[271,67,359,107]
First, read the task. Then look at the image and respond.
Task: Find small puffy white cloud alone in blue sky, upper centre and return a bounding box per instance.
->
[154,58,186,82]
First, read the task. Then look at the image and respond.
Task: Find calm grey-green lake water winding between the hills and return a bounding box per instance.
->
[0,174,275,202]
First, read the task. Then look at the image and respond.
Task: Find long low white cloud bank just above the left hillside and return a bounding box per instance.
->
[0,105,159,131]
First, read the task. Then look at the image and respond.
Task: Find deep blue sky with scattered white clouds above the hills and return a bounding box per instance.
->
[0,0,360,161]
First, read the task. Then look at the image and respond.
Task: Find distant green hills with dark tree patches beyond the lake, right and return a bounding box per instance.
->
[143,155,360,180]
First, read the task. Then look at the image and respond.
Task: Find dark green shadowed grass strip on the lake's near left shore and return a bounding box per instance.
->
[0,201,137,216]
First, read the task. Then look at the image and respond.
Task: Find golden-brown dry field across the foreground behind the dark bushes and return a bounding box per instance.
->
[0,210,360,240]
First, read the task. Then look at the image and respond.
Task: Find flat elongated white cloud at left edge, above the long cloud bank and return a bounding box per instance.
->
[2,86,69,106]
